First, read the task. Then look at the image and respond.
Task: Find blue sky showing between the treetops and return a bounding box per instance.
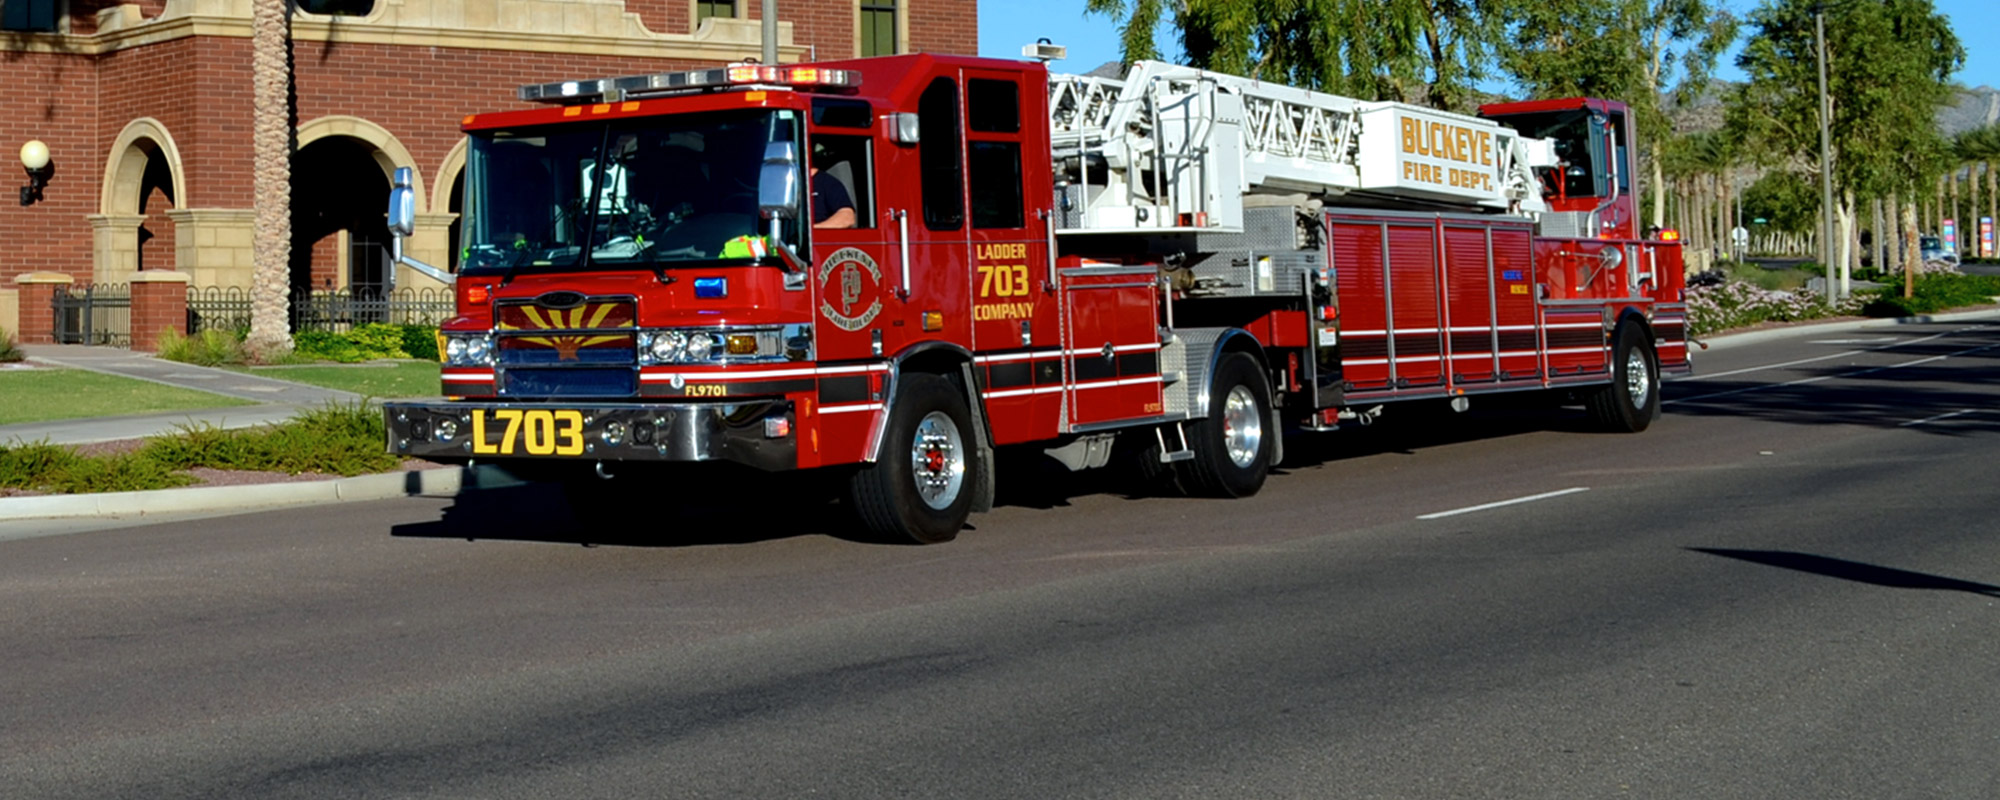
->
[980,0,2000,90]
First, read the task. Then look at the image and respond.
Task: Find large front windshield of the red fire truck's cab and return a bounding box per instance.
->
[460,110,804,274]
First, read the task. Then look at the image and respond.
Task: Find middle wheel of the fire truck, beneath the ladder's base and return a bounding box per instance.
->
[1174,352,1278,498]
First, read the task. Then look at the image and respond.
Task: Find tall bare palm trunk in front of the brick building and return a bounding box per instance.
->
[244,0,292,360]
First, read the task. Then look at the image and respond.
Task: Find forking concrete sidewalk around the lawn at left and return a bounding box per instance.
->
[0,344,362,444]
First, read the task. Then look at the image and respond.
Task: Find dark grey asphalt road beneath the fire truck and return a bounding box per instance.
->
[0,322,2000,798]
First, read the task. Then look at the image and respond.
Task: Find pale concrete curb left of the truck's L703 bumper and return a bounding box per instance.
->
[0,466,470,520]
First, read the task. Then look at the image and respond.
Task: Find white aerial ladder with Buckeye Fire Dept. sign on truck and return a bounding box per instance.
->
[1048,62,1556,234]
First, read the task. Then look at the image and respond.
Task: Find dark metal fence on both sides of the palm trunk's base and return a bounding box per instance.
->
[188,286,458,332]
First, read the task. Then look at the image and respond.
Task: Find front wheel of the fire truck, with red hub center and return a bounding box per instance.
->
[848,374,986,544]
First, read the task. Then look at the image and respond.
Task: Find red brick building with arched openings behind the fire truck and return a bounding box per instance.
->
[0,0,978,340]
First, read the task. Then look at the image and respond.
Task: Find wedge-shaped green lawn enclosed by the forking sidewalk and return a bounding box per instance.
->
[0,370,252,424]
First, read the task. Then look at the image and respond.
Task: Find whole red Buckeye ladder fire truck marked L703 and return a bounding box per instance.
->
[386,54,1688,542]
